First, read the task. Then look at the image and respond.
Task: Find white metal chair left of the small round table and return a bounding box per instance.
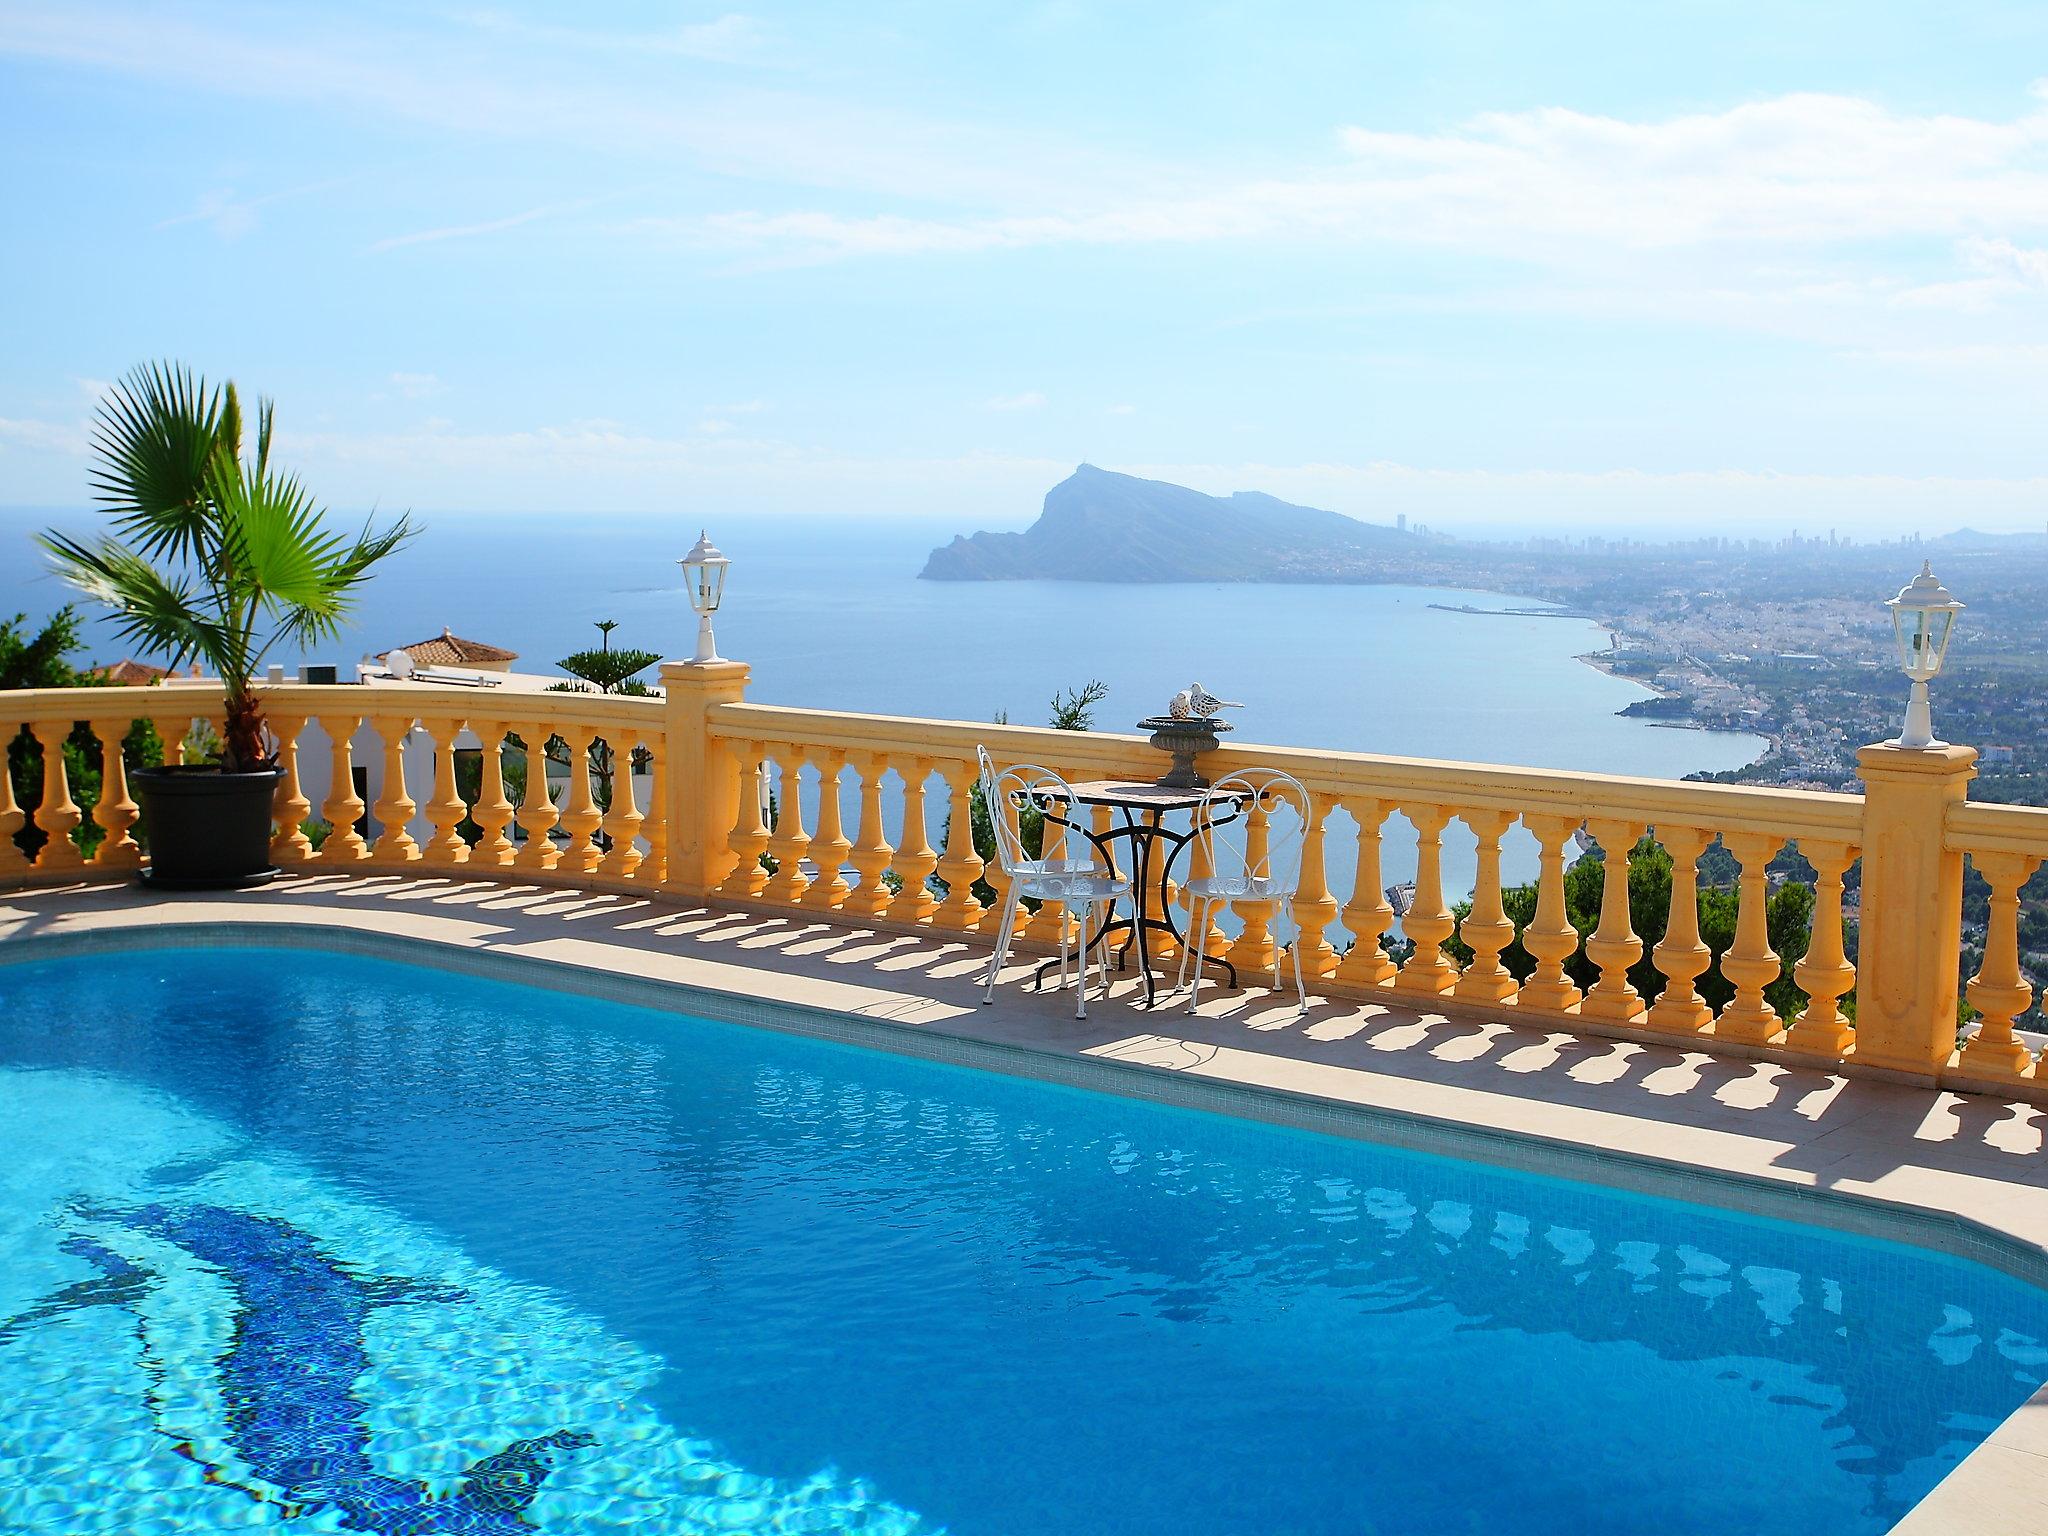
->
[975,748,1130,1018]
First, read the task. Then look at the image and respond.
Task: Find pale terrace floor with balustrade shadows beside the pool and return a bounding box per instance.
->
[0,874,2048,1536]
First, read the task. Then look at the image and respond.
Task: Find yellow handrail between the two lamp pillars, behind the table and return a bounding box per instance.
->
[709,702,1867,844]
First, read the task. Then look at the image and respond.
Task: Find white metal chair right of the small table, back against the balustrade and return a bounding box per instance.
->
[1176,768,1309,1014]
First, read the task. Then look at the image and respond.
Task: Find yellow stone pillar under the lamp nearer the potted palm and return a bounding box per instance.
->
[655,662,748,897]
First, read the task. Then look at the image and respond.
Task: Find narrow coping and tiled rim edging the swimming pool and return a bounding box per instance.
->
[0,888,2048,1536]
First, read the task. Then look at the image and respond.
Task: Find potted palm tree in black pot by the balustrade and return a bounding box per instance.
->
[43,362,416,889]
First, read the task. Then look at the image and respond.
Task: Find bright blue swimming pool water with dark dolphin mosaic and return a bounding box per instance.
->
[0,950,2048,1536]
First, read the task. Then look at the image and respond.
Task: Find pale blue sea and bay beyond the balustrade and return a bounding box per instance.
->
[0,518,1767,895]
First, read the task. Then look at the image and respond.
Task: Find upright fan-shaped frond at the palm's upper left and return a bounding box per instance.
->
[90,362,221,559]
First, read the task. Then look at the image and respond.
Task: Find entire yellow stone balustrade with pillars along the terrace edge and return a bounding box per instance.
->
[0,662,2048,1096]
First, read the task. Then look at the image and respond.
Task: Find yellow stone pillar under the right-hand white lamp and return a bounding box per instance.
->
[1855,741,1976,1077]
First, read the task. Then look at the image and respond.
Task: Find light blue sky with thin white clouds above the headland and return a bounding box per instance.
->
[0,0,2048,537]
